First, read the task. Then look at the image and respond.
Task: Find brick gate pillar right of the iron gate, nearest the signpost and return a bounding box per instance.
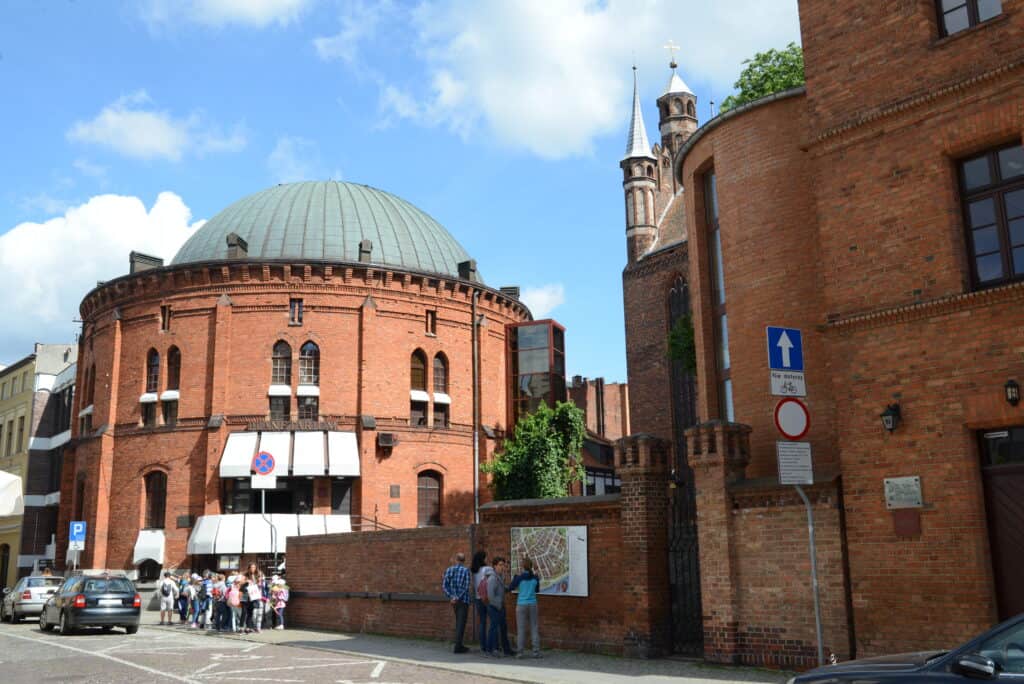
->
[685,421,751,662]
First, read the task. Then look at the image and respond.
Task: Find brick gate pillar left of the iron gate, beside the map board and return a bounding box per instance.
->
[615,434,672,657]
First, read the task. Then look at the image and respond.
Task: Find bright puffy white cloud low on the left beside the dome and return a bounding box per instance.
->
[0,193,204,361]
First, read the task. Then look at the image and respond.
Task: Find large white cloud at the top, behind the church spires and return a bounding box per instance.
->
[317,0,800,159]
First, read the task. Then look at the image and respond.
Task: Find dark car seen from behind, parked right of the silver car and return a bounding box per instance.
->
[39,574,142,634]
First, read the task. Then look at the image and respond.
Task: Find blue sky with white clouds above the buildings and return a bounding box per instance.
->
[0,0,800,382]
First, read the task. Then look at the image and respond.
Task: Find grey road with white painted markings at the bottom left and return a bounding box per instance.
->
[0,623,502,684]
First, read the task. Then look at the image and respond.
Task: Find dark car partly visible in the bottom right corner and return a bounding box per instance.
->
[788,613,1024,684]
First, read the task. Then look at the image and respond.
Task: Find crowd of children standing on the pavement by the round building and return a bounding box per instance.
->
[157,563,289,634]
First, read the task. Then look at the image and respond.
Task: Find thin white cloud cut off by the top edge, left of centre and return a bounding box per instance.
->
[141,0,312,29]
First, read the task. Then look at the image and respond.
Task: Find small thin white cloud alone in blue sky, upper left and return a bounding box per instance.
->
[68,90,246,162]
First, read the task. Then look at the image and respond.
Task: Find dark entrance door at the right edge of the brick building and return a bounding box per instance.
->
[981,427,1024,619]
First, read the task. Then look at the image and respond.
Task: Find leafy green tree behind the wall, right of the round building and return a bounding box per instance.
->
[481,401,587,501]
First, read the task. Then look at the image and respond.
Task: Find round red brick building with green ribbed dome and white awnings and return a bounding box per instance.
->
[57,181,536,578]
